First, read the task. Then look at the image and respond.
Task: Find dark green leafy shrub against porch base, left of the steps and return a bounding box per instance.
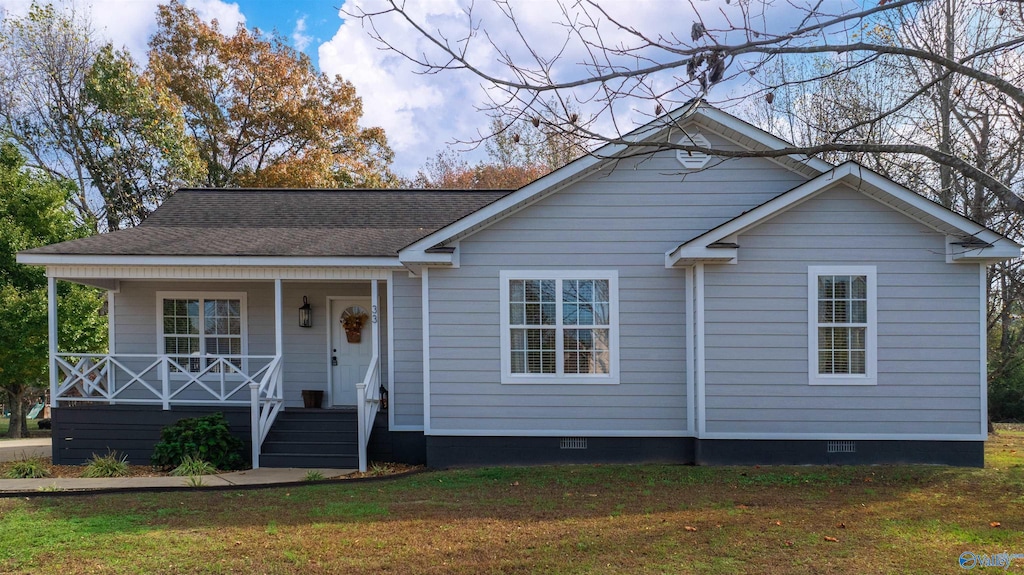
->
[153,412,245,470]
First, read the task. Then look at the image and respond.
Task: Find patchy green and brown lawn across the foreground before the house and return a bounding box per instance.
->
[0,428,1024,574]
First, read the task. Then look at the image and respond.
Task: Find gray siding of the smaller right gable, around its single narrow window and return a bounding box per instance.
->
[705,187,982,437]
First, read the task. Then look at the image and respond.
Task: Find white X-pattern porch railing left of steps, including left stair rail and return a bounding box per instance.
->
[50,353,284,469]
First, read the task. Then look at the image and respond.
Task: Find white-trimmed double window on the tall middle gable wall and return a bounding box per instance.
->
[501,271,618,384]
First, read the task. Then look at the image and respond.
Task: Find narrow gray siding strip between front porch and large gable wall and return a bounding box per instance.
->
[389,271,423,428]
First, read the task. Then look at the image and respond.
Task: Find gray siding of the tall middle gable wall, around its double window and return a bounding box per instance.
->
[423,130,804,435]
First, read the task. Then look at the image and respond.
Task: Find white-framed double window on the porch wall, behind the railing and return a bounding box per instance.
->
[157,292,247,373]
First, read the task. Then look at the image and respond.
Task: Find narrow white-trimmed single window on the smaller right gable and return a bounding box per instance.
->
[808,266,878,385]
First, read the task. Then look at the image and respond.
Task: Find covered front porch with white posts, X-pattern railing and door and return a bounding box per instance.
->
[41,266,391,471]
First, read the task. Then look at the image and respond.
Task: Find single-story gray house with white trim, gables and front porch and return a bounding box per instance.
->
[18,104,1021,468]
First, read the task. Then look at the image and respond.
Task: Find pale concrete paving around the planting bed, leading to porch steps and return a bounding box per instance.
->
[0,438,355,493]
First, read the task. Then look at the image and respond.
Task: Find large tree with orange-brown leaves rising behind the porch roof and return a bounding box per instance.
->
[148,0,394,187]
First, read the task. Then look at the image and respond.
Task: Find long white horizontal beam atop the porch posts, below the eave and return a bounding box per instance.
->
[39,265,388,284]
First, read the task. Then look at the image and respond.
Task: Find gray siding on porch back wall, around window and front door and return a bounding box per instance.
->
[114,280,388,407]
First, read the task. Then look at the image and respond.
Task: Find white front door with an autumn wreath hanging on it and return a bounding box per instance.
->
[331,298,374,405]
